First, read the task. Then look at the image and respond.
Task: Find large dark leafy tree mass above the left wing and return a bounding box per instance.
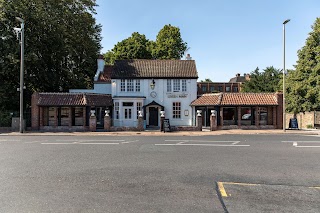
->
[0,0,101,109]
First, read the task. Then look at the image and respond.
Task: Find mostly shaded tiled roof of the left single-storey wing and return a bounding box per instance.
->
[38,93,112,106]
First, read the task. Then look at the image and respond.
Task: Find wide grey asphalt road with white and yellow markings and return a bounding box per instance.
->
[0,134,320,213]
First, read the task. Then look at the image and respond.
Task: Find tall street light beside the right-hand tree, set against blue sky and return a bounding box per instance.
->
[282,19,290,132]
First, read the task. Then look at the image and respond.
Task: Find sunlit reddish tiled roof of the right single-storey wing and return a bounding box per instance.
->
[191,93,278,106]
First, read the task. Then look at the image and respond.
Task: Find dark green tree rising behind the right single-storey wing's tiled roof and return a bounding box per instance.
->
[241,66,281,92]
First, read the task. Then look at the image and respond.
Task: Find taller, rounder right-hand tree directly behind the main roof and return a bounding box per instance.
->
[152,24,187,59]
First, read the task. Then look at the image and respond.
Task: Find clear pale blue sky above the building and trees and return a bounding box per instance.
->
[95,0,320,82]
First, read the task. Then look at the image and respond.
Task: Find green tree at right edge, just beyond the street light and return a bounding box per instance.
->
[286,18,320,113]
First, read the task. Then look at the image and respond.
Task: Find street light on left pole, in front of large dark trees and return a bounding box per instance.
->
[15,17,24,133]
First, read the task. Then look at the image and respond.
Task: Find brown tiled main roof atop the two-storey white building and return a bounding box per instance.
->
[111,59,198,79]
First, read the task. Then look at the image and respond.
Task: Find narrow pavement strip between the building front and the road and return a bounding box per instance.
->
[0,129,320,136]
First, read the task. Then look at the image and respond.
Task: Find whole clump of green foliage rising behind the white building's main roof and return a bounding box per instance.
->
[104,25,187,64]
